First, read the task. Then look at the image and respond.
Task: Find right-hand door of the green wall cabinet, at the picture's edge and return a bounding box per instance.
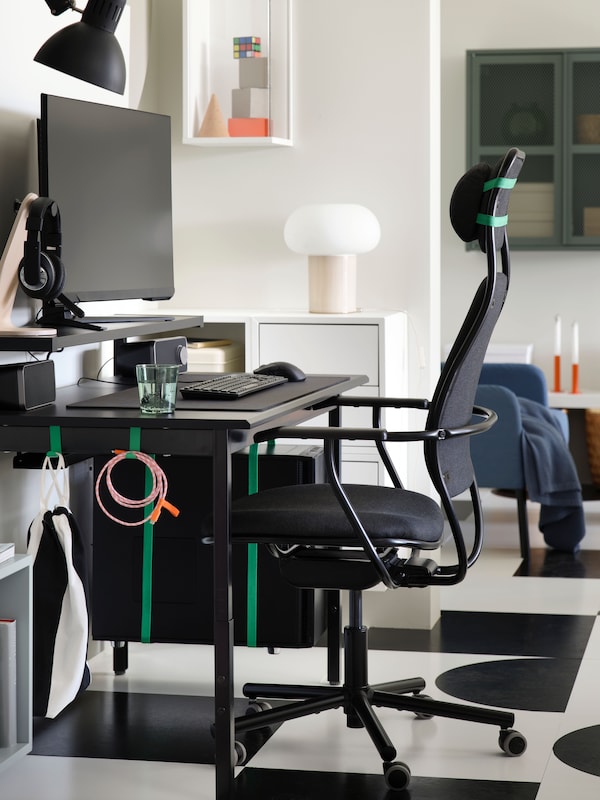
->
[565,53,600,247]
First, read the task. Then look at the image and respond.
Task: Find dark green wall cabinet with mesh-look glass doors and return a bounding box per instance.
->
[467,49,600,249]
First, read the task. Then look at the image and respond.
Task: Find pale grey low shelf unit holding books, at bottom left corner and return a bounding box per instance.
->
[0,555,33,772]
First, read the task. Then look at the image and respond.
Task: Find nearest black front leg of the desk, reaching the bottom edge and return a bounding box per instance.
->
[213,431,235,800]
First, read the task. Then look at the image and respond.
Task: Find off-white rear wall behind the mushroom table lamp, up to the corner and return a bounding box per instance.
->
[153,0,439,406]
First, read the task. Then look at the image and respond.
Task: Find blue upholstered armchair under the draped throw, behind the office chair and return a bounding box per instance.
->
[471,364,569,562]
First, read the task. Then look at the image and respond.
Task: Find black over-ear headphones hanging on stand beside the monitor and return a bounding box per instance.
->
[18,197,65,300]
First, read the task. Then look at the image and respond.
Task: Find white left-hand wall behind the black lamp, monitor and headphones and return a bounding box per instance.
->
[0,0,139,552]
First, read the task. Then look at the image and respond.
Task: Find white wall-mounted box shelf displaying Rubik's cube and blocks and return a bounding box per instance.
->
[183,0,292,147]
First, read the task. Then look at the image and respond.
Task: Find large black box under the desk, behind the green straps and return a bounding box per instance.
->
[91,445,326,647]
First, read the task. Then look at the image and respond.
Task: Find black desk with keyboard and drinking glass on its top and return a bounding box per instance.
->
[0,375,367,800]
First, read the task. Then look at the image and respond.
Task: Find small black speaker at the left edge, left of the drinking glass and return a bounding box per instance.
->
[0,361,56,411]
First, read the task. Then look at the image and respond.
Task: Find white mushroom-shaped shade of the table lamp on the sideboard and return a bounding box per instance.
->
[283,203,381,256]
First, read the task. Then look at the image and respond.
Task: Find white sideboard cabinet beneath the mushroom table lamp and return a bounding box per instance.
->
[173,309,408,484]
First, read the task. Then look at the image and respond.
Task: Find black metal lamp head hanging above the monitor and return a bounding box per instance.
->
[34,0,127,94]
